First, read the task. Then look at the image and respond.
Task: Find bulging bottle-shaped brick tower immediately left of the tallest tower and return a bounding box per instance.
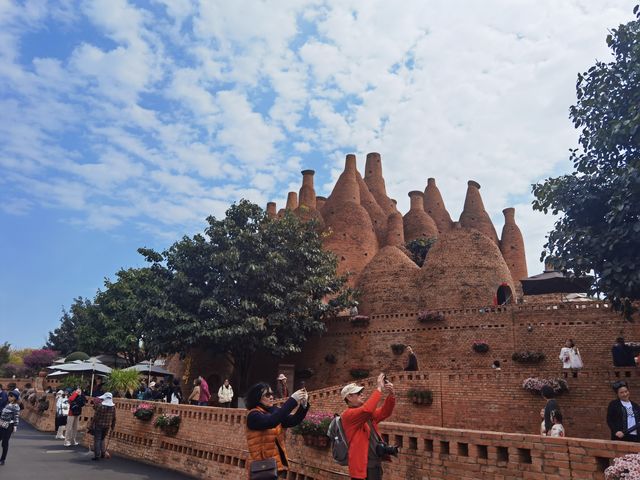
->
[322,155,378,286]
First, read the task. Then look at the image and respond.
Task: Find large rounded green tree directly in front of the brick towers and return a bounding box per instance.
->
[140,200,352,387]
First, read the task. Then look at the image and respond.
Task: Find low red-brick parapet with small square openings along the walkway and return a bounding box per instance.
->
[20,398,638,480]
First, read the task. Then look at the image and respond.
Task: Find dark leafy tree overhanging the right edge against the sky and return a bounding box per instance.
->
[533,6,640,298]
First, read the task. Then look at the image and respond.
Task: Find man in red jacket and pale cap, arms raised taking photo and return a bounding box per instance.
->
[341,373,396,480]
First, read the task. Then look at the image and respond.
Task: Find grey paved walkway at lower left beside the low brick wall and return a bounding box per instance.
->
[0,421,191,480]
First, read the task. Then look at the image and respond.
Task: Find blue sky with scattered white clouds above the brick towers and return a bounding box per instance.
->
[0,0,634,347]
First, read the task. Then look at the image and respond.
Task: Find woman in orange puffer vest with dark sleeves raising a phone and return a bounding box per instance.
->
[245,383,309,478]
